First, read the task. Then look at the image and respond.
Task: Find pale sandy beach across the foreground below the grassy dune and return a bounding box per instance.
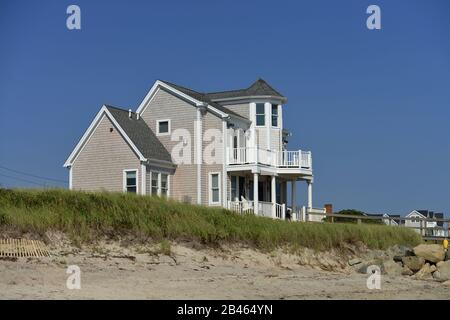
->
[0,245,450,299]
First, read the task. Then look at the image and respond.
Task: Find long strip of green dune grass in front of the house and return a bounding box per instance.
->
[0,189,421,250]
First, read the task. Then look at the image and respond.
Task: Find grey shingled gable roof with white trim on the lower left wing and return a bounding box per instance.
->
[64,105,173,167]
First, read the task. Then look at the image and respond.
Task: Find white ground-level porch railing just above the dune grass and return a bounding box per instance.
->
[228,201,286,220]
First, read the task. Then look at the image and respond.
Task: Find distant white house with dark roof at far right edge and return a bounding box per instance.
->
[405,210,446,237]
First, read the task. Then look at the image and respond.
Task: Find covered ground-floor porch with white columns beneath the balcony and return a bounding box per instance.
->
[227,171,313,220]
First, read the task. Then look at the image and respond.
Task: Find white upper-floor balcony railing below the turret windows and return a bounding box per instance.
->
[227,147,312,169]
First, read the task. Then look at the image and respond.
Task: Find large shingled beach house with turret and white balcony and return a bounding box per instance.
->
[64,79,313,218]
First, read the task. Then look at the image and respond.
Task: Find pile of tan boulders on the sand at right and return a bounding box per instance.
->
[349,244,450,283]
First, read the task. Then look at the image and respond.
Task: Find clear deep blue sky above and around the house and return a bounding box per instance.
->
[0,0,450,214]
